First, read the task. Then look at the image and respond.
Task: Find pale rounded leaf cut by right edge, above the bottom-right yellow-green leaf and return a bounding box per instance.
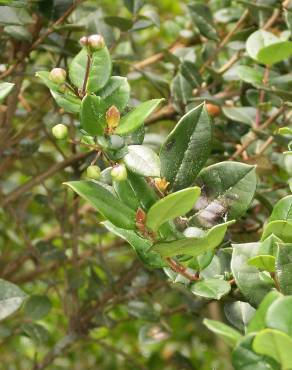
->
[266,297,292,336]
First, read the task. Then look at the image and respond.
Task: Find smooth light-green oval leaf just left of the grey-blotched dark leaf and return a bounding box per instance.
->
[146,186,201,231]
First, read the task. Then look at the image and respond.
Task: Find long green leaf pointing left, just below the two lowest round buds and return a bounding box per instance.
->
[65,181,136,229]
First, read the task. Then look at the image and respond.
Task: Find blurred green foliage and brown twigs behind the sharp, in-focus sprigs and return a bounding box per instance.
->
[0,0,292,370]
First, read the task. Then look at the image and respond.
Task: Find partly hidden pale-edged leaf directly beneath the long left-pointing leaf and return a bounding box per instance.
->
[102,221,165,268]
